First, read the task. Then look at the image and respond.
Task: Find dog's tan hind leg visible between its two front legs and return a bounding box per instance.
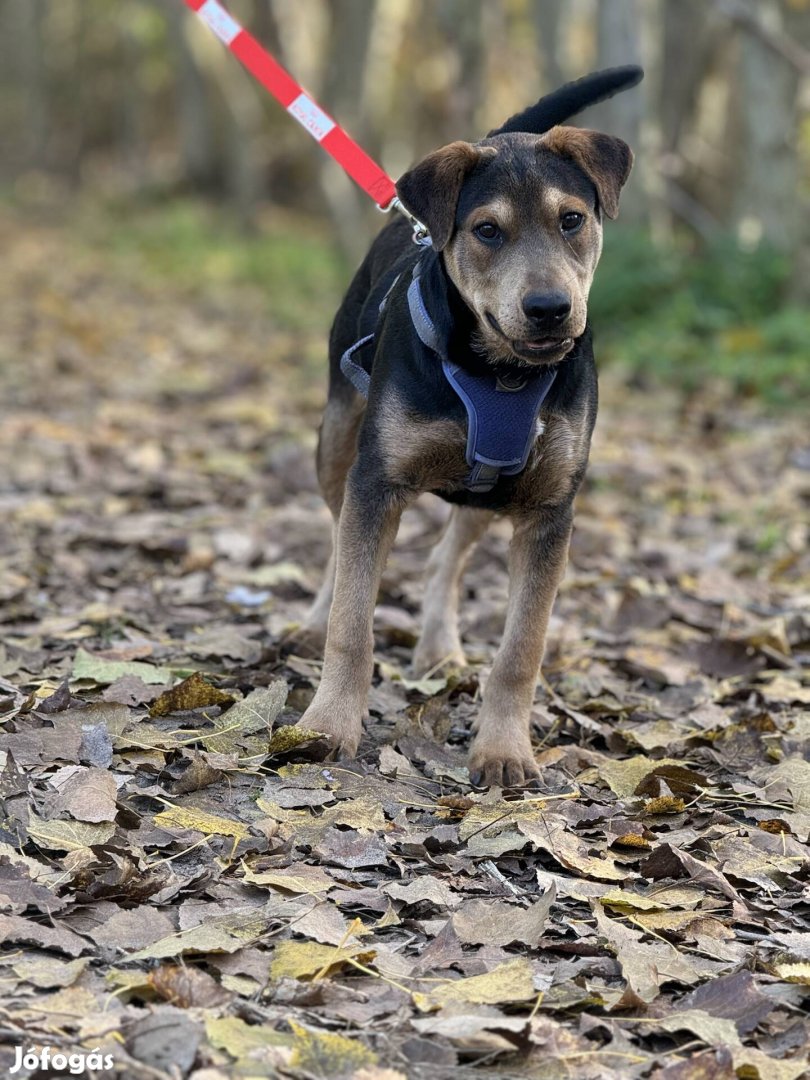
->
[414,507,494,675]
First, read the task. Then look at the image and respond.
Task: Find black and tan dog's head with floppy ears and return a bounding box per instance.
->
[396,127,633,364]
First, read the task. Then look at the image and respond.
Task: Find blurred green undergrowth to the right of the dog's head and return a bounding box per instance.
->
[591,231,810,405]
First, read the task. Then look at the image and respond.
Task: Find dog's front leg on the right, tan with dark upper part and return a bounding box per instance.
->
[470,511,571,786]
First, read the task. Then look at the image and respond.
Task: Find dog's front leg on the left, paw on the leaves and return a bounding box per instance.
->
[298,470,407,757]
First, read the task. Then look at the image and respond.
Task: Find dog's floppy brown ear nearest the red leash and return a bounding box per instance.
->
[396,143,497,252]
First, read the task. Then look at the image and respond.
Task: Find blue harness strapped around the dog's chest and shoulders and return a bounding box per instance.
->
[340,259,557,492]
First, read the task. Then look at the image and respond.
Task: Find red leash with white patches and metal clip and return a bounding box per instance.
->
[178,0,430,243]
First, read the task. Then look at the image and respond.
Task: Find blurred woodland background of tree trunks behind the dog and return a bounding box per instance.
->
[0,0,810,397]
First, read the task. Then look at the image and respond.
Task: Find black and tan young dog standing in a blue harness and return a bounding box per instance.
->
[296,67,643,787]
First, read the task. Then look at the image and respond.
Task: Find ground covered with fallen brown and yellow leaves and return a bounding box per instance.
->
[0,204,810,1080]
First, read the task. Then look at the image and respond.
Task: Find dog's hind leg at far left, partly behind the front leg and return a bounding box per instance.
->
[285,393,365,656]
